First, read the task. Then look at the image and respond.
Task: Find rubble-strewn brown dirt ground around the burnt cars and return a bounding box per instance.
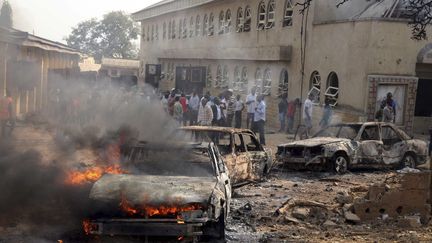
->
[0,126,432,242]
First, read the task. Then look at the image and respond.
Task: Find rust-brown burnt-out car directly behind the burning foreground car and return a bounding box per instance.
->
[180,126,273,188]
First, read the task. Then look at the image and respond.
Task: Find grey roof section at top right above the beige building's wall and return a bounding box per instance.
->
[315,0,409,22]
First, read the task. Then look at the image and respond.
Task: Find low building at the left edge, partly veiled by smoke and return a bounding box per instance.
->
[0,27,80,116]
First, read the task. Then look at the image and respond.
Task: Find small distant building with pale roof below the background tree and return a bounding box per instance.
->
[99,58,139,88]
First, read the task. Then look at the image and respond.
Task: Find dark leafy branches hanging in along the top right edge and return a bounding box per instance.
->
[296,0,432,40]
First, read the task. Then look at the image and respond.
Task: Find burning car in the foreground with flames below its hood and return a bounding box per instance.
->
[84,142,231,240]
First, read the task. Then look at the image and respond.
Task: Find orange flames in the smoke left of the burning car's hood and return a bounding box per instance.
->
[65,165,126,185]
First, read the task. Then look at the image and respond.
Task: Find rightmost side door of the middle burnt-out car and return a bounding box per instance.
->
[242,133,269,180]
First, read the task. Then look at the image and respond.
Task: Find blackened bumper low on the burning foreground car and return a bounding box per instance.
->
[86,219,208,237]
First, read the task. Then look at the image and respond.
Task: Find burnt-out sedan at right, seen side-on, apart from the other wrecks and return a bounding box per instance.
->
[276,122,427,173]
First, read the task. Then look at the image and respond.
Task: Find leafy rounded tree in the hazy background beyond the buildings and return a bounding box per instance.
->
[66,11,139,60]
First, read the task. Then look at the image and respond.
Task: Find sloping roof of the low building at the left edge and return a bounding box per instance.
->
[0,27,80,55]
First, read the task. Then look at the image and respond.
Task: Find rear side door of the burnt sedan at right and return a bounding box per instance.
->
[381,125,406,165]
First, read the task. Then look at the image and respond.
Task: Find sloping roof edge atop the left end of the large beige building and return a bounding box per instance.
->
[132,0,217,21]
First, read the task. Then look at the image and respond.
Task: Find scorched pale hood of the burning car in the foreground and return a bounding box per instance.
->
[90,174,217,205]
